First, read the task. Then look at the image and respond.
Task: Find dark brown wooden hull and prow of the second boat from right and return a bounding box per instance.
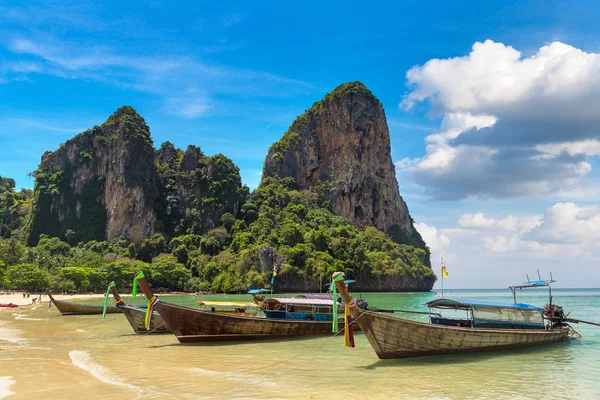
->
[138,278,342,343]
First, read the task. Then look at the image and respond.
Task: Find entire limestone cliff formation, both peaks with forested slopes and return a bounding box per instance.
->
[17,95,435,292]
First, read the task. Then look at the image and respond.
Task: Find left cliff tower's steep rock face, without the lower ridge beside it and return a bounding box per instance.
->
[28,107,156,244]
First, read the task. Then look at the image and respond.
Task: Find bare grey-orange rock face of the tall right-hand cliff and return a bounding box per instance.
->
[263,82,429,253]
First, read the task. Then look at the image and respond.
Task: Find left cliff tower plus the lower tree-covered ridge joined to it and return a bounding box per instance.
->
[26,107,248,245]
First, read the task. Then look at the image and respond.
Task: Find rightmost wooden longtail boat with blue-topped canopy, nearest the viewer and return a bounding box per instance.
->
[333,272,584,359]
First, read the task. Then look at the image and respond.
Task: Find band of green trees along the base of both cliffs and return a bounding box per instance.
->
[0,178,435,292]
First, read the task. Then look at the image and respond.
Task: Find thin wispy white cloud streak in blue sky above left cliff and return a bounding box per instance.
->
[0,36,312,118]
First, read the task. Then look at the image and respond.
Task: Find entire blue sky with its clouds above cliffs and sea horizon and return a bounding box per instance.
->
[0,1,600,287]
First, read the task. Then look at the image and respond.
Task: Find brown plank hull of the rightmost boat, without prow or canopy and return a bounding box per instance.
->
[353,310,570,359]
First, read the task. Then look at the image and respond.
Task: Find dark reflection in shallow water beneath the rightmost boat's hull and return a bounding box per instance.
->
[357,342,573,370]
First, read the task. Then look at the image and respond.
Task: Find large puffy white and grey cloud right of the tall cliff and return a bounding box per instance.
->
[400,40,600,199]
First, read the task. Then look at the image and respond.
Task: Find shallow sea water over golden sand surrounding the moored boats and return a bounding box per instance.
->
[0,289,600,399]
